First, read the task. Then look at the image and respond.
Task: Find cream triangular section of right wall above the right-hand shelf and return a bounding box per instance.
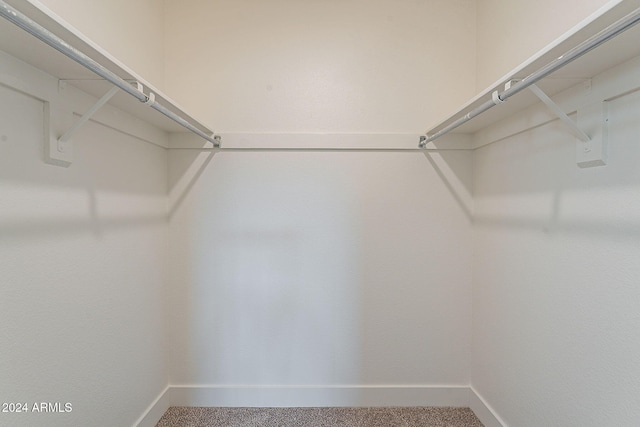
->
[476,0,619,91]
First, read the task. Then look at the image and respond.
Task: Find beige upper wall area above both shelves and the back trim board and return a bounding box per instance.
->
[30,0,620,126]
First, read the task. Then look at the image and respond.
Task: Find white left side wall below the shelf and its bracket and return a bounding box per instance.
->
[0,54,168,426]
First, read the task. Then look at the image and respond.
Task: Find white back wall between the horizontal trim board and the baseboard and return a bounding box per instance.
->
[169,145,471,405]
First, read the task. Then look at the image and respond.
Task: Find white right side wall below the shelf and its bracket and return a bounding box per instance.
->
[472,53,640,427]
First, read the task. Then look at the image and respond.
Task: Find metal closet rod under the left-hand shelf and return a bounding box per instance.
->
[0,0,220,147]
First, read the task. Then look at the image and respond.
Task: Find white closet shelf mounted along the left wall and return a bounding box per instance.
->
[0,0,213,140]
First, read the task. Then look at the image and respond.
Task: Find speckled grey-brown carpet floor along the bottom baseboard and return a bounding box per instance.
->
[156,406,483,427]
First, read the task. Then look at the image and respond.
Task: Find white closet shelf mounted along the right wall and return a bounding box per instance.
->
[426,0,640,142]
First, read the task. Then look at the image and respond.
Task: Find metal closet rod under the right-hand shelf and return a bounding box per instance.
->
[419,8,640,148]
